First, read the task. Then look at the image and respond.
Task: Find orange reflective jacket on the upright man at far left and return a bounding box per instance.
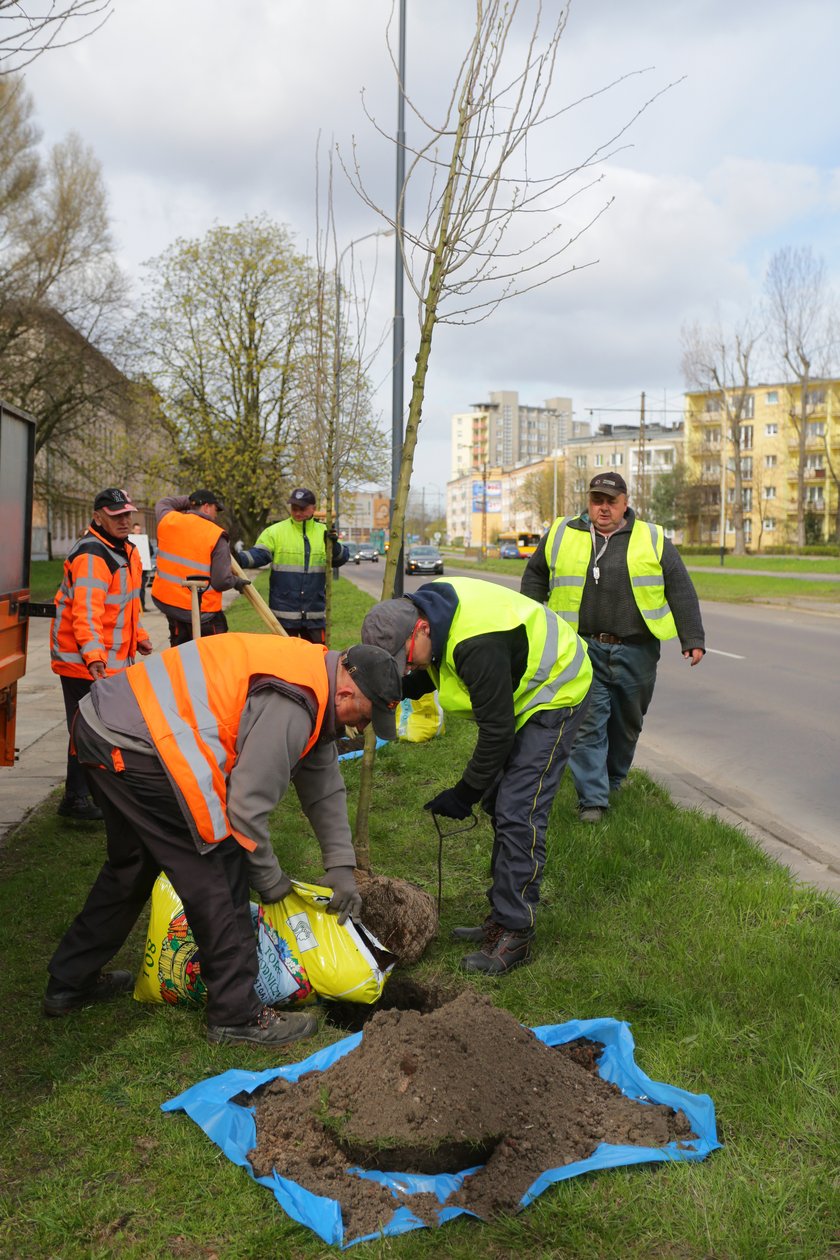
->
[49,525,149,679]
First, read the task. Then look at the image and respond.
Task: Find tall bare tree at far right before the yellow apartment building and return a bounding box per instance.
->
[764,246,837,546]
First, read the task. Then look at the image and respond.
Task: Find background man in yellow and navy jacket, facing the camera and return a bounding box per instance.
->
[236,486,349,643]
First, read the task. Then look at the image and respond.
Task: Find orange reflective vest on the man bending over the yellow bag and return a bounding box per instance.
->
[126,634,329,849]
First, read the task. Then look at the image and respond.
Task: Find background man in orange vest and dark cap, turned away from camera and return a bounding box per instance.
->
[151,490,248,648]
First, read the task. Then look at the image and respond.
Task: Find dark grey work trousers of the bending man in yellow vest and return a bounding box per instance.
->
[482,696,589,931]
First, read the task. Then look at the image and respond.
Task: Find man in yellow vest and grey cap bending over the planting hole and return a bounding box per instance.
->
[361,577,592,975]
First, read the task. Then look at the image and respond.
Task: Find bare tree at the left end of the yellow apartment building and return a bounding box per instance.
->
[683,318,761,556]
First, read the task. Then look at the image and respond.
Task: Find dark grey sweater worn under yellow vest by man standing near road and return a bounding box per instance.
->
[520,508,705,651]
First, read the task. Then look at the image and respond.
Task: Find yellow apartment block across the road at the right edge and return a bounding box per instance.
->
[685,379,840,551]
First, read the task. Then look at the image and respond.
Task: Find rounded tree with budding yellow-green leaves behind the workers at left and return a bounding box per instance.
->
[135,217,317,541]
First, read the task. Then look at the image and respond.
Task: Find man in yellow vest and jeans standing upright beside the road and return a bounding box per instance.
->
[521,471,705,823]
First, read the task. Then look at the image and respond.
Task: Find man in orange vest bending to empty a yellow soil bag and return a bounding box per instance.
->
[44,634,400,1046]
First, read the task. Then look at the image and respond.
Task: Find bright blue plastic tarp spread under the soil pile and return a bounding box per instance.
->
[161,1018,720,1247]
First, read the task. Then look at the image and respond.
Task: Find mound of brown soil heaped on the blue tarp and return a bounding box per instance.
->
[248,989,693,1241]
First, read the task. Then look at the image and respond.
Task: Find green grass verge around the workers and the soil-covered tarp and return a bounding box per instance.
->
[0,577,840,1260]
